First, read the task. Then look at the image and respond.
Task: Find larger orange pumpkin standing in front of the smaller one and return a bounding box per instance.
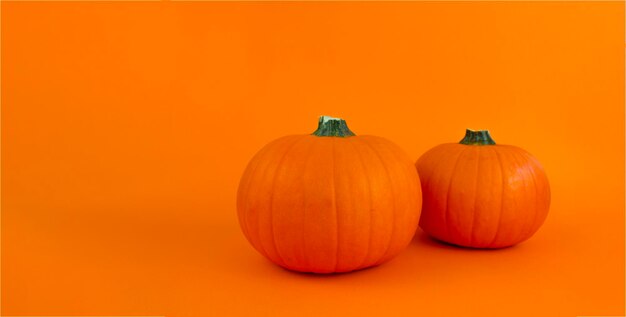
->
[237,116,421,273]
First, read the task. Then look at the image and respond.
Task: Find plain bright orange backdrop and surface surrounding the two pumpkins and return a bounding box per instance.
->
[1,2,624,316]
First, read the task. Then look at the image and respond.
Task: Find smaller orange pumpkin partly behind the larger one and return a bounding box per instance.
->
[417,130,550,248]
